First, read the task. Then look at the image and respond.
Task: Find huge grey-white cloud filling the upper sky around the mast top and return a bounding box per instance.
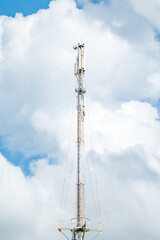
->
[0,0,159,157]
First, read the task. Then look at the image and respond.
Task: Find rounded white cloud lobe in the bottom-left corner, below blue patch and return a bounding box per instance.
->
[0,155,37,239]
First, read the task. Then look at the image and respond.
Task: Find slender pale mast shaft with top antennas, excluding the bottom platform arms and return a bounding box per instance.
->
[74,44,86,231]
